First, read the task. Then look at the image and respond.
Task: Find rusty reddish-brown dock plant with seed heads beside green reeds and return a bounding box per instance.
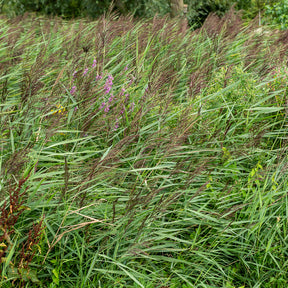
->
[0,176,43,286]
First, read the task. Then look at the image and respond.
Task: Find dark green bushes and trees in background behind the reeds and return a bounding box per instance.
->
[0,0,287,28]
